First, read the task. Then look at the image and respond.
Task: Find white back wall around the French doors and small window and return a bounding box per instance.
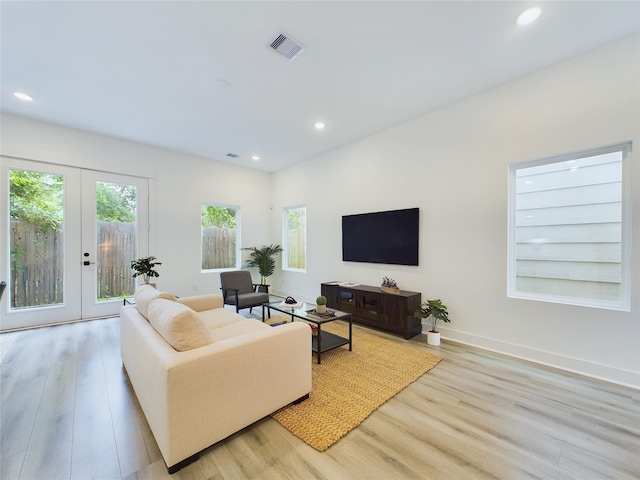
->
[0,115,272,296]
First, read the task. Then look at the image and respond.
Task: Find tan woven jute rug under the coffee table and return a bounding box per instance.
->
[271,322,441,452]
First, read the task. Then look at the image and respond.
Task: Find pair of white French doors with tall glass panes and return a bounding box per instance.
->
[0,157,149,330]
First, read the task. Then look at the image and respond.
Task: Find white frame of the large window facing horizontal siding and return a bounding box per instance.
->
[507,141,632,312]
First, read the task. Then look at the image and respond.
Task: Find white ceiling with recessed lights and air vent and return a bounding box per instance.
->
[0,0,640,171]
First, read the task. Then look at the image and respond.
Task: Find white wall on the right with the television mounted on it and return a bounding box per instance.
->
[273,36,640,387]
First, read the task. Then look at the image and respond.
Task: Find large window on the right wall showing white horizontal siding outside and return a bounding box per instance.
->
[508,143,631,311]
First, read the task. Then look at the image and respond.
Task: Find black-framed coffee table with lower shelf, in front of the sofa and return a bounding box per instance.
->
[262,302,353,364]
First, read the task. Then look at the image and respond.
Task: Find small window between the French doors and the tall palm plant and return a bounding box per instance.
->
[201,204,240,270]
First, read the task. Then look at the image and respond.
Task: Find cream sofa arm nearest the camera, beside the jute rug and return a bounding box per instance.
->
[159,319,312,465]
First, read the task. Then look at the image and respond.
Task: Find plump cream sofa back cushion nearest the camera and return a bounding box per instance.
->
[149,298,213,352]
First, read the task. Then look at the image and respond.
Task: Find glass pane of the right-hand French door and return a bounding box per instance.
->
[96,182,138,301]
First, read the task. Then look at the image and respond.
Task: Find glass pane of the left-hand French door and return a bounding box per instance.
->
[7,170,64,309]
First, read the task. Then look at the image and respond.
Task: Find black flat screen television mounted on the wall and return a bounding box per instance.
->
[342,208,420,265]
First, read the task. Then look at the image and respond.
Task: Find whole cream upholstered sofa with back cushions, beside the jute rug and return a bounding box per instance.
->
[120,285,311,473]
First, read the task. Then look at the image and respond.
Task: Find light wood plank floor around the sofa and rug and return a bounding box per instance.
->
[0,318,640,480]
